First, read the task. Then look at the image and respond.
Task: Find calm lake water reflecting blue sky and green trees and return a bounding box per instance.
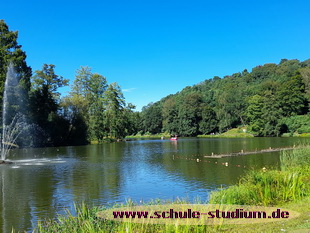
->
[0,138,309,232]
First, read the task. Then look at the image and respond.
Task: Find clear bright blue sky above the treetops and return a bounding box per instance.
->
[0,0,310,110]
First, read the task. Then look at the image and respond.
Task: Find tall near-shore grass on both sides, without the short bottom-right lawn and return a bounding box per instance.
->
[34,146,310,233]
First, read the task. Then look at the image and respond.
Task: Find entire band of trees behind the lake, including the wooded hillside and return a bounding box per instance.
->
[0,20,310,146]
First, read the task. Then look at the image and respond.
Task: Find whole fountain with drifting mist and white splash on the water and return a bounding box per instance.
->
[0,63,62,165]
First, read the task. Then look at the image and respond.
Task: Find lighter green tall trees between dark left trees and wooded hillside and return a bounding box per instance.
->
[64,67,133,142]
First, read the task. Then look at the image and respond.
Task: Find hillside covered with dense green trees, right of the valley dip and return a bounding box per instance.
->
[139,59,310,136]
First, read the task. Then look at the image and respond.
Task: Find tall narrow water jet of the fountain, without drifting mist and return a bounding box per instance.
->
[0,63,24,164]
